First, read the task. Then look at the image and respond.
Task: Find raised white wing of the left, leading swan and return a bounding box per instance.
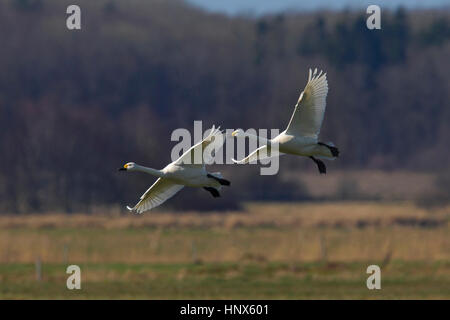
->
[174,126,225,166]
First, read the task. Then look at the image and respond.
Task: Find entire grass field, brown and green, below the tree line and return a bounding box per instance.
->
[0,202,450,299]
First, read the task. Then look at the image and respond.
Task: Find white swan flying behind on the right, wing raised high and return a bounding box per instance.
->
[232,68,339,173]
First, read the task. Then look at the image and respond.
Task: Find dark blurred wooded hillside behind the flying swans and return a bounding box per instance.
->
[0,0,450,212]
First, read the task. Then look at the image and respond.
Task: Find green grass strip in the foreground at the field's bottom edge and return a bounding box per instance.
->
[0,261,450,299]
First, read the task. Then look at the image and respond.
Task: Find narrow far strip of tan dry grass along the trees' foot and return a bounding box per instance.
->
[0,202,450,230]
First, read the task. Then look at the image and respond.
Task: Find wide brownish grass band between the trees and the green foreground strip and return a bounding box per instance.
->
[0,202,450,263]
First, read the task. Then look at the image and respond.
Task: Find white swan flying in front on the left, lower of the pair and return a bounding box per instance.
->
[119,126,230,213]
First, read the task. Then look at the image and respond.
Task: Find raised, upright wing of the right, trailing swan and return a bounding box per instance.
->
[286,68,328,137]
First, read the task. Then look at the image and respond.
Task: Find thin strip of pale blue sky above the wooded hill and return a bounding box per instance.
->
[187,0,450,15]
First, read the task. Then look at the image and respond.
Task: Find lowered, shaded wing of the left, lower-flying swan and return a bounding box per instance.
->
[127,178,184,213]
